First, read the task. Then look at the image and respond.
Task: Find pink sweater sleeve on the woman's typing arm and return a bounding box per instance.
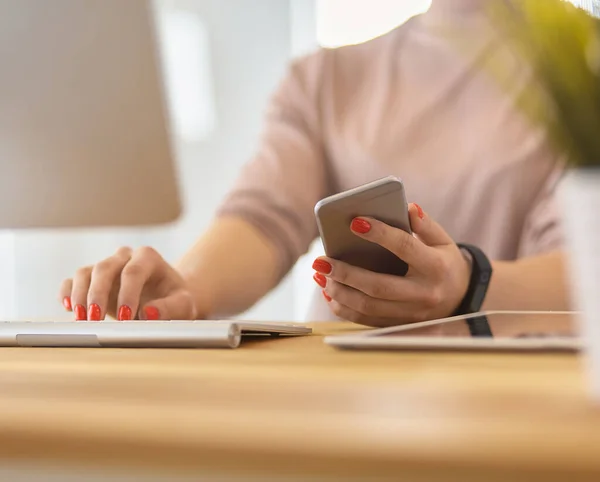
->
[217,51,330,279]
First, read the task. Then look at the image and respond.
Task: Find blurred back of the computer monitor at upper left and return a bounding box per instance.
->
[0,0,181,229]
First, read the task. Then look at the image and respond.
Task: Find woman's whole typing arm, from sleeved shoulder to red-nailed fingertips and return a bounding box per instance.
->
[59,52,329,321]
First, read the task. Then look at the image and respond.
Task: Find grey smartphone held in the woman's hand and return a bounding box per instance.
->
[315,176,412,276]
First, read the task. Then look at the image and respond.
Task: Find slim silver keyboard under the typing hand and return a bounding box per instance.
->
[0,320,312,348]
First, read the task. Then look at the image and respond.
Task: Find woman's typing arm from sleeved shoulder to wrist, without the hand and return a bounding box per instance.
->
[178,52,329,317]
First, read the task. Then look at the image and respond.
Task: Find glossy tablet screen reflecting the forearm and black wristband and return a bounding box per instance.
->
[374,312,578,338]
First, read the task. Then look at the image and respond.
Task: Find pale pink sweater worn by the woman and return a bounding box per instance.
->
[219,0,562,288]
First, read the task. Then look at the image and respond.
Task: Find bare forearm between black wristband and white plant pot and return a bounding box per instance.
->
[483,251,571,311]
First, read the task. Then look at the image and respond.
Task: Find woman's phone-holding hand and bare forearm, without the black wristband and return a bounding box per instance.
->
[314,204,569,326]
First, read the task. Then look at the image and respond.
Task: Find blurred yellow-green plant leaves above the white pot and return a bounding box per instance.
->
[500,0,600,167]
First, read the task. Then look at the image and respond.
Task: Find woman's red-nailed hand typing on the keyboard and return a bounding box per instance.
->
[60,247,198,321]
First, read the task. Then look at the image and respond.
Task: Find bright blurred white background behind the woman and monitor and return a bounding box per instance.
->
[0,0,598,320]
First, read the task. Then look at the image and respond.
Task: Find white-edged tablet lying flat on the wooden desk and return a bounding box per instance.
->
[325,311,581,352]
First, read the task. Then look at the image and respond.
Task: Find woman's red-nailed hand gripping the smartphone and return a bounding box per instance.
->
[313,204,471,326]
